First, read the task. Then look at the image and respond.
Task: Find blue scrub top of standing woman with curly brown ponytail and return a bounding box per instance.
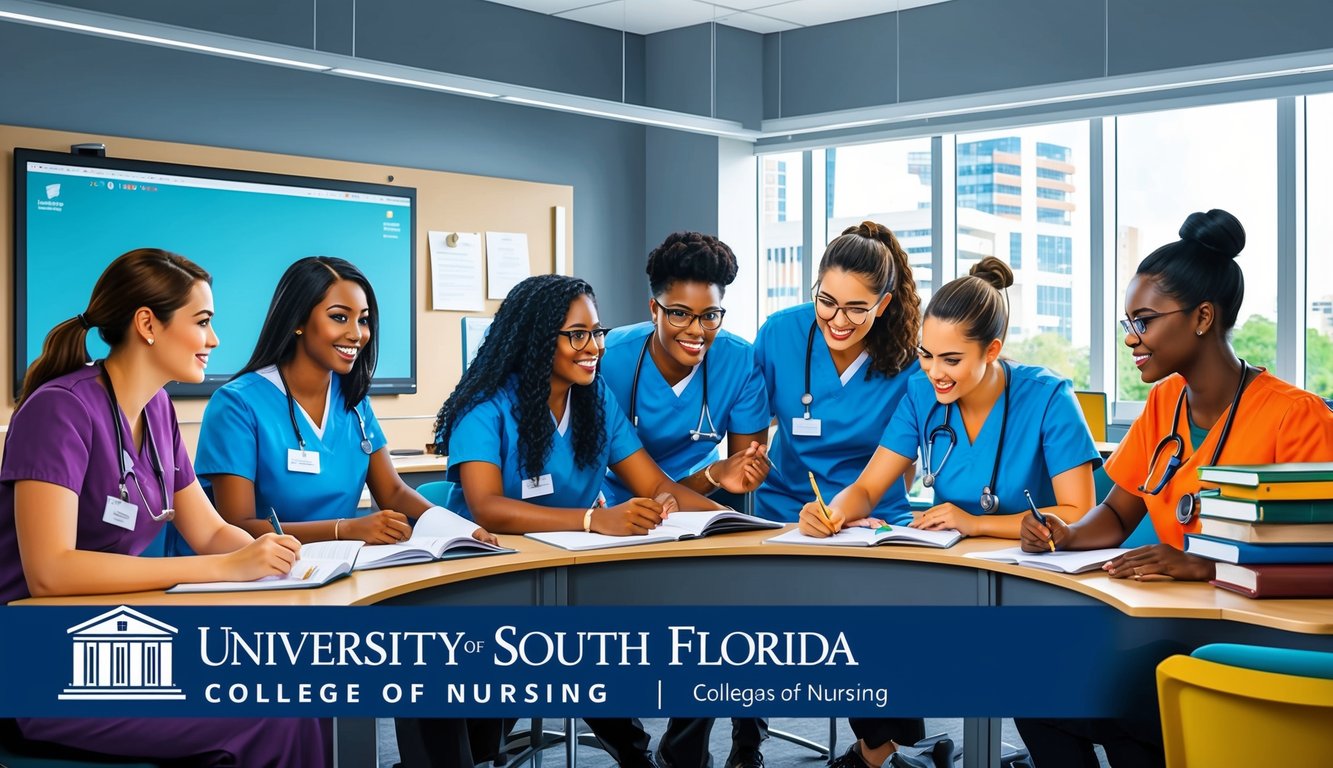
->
[754,303,921,524]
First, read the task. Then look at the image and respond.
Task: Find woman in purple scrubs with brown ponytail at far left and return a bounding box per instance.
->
[0,248,329,767]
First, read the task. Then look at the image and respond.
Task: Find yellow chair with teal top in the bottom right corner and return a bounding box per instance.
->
[1157,644,1333,768]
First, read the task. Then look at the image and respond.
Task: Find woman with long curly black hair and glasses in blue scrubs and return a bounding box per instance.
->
[436,275,720,768]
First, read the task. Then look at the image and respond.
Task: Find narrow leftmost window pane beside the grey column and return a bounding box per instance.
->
[758,152,805,320]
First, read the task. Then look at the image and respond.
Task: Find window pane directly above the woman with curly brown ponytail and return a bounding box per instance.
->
[825,139,933,305]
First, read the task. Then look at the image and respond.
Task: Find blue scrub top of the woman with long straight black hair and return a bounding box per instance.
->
[195,372,387,523]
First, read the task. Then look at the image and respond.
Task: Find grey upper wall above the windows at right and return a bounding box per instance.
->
[762,0,1333,119]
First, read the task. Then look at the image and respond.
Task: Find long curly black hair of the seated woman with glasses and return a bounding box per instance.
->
[435,275,607,477]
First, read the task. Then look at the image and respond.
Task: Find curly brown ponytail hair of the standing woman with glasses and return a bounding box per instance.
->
[820,221,921,377]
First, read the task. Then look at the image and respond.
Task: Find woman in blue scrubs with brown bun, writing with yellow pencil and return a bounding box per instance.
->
[801,256,1101,768]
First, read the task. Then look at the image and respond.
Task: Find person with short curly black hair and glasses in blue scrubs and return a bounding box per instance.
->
[601,232,770,768]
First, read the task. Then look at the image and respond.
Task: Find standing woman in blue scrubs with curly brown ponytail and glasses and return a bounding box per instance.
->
[754,221,921,523]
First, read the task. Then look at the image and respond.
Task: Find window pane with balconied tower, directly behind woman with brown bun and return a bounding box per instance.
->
[956,121,1092,388]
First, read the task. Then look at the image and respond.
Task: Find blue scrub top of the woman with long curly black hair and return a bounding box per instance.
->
[445,376,643,520]
